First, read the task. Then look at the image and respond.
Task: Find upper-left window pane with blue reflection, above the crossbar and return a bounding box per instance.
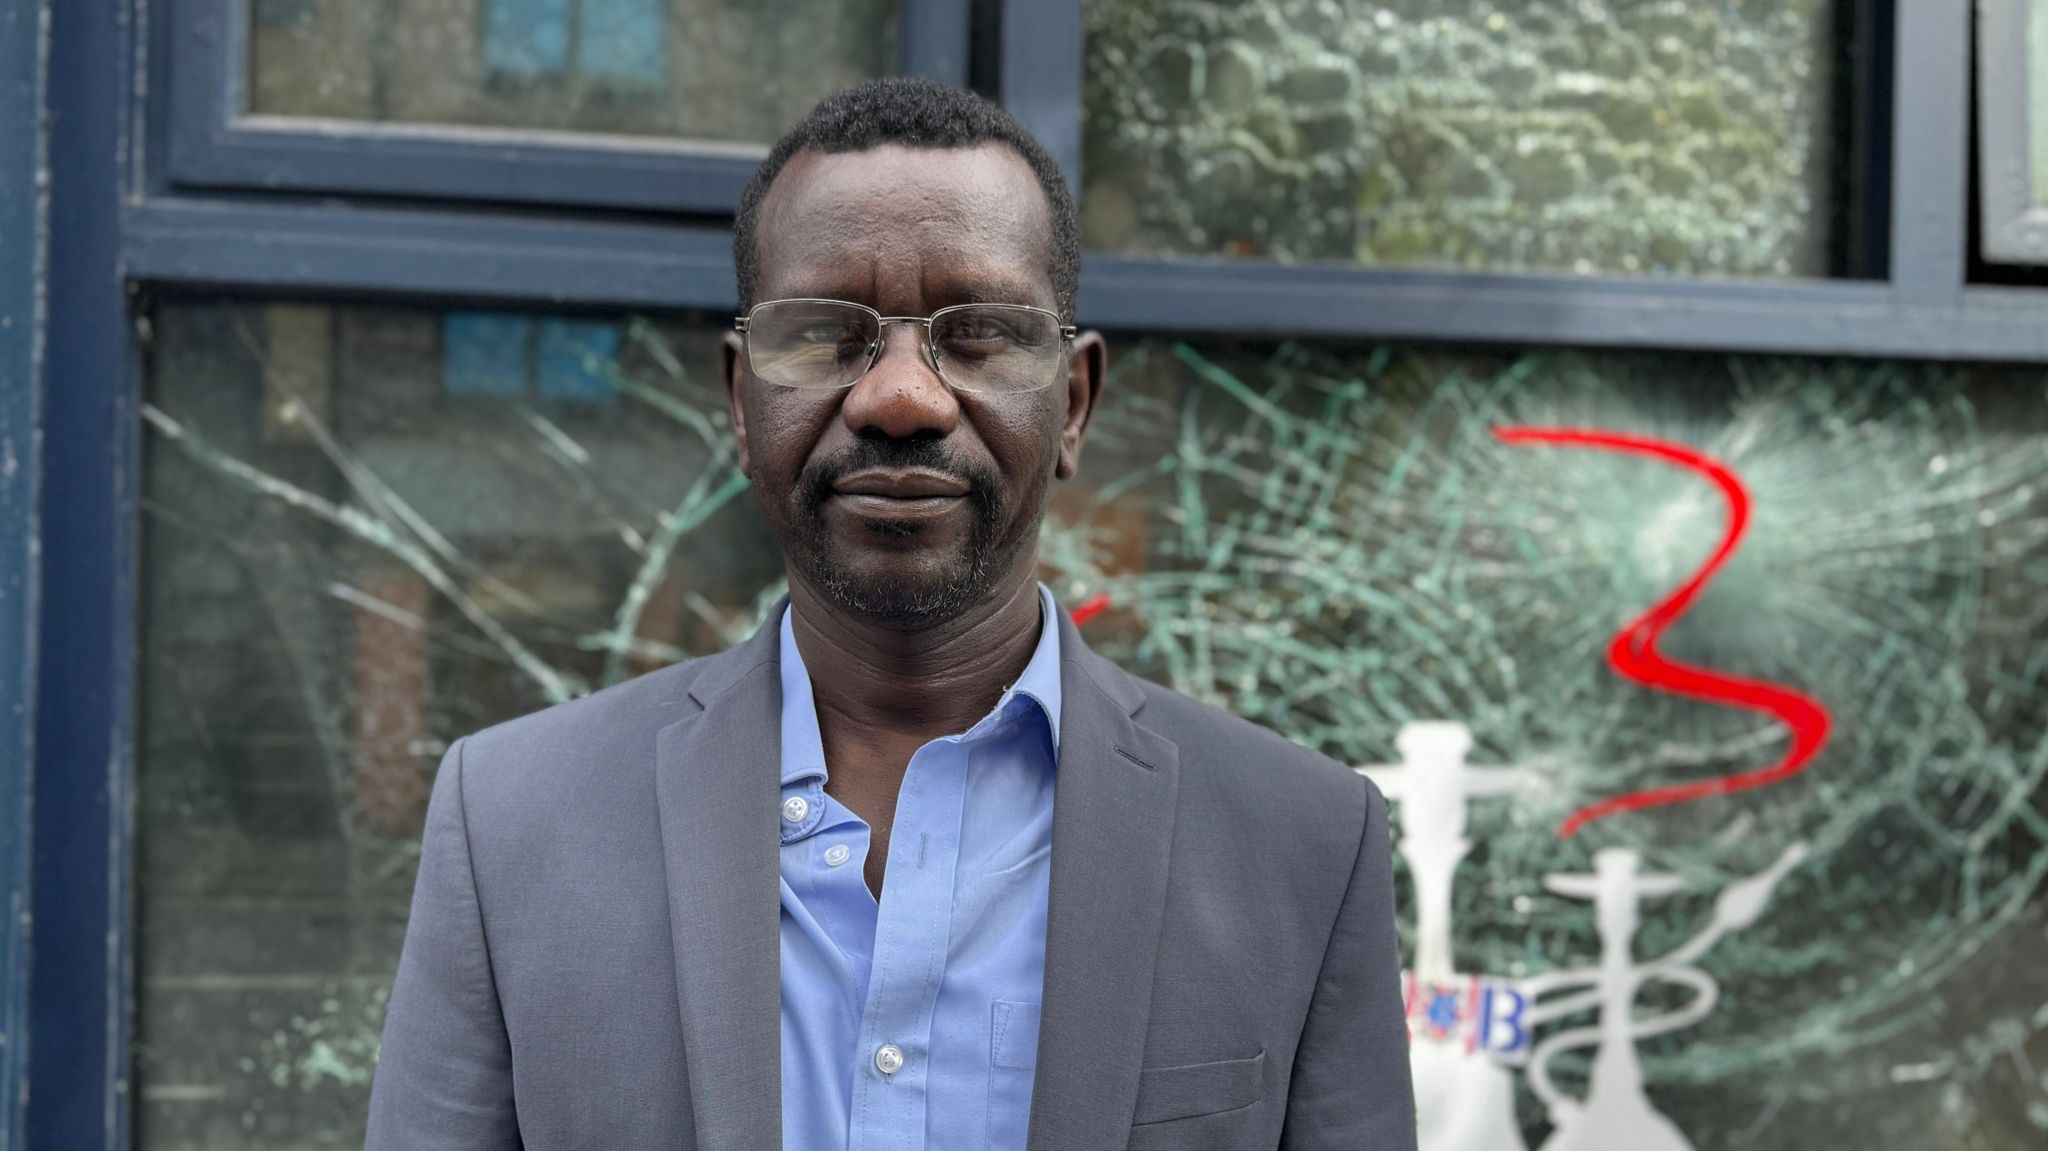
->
[248,0,899,143]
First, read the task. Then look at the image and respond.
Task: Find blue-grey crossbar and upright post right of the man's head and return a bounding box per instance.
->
[1079,0,2048,360]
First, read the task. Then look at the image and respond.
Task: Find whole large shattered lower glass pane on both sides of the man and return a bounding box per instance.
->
[137,301,2048,1151]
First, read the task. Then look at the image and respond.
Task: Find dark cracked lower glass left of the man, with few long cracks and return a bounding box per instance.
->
[137,303,780,1151]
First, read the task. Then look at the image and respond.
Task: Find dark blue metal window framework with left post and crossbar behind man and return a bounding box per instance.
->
[19,0,2048,1151]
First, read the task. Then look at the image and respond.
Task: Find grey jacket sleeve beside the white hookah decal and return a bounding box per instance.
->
[1280,776,1415,1151]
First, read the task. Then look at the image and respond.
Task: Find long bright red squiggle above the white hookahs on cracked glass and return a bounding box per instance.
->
[1493,428,1831,838]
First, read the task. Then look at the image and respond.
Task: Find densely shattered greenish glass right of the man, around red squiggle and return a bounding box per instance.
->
[1049,342,2048,1149]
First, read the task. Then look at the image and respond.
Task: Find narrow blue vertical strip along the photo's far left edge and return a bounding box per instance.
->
[0,0,49,1151]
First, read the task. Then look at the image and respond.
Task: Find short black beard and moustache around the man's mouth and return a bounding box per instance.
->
[786,436,1004,631]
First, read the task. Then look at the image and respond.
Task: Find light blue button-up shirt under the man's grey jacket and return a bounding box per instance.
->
[780,584,1059,1151]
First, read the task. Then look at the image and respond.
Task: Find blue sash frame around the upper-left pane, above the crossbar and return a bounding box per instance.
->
[164,0,969,213]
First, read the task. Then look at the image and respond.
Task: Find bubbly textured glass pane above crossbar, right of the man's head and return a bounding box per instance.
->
[1081,0,1845,276]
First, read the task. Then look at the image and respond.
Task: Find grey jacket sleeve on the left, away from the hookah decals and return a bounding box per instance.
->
[365,739,520,1151]
